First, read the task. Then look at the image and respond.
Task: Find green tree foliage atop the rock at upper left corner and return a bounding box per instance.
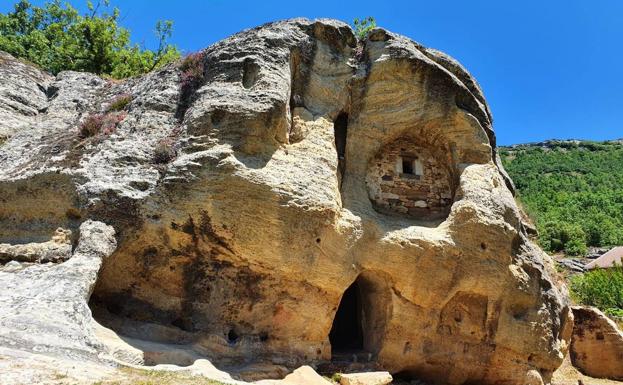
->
[0,0,180,78]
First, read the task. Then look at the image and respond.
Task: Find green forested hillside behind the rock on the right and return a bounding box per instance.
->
[500,140,623,255]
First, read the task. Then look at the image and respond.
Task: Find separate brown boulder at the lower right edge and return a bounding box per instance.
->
[570,306,623,380]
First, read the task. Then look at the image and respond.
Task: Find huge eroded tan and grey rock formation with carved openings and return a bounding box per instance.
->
[0,19,571,384]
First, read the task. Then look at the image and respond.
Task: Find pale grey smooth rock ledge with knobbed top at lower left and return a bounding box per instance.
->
[0,221,116,360]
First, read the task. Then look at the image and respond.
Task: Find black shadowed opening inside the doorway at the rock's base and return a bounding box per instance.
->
[329,281,363,355]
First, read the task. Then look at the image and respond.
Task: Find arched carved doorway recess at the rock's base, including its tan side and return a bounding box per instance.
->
[329,272,391,361]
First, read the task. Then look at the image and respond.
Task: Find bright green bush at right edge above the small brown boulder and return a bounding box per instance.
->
[570,266,623,315]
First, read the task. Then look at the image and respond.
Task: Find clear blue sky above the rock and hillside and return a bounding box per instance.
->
[0,0,623,144]
